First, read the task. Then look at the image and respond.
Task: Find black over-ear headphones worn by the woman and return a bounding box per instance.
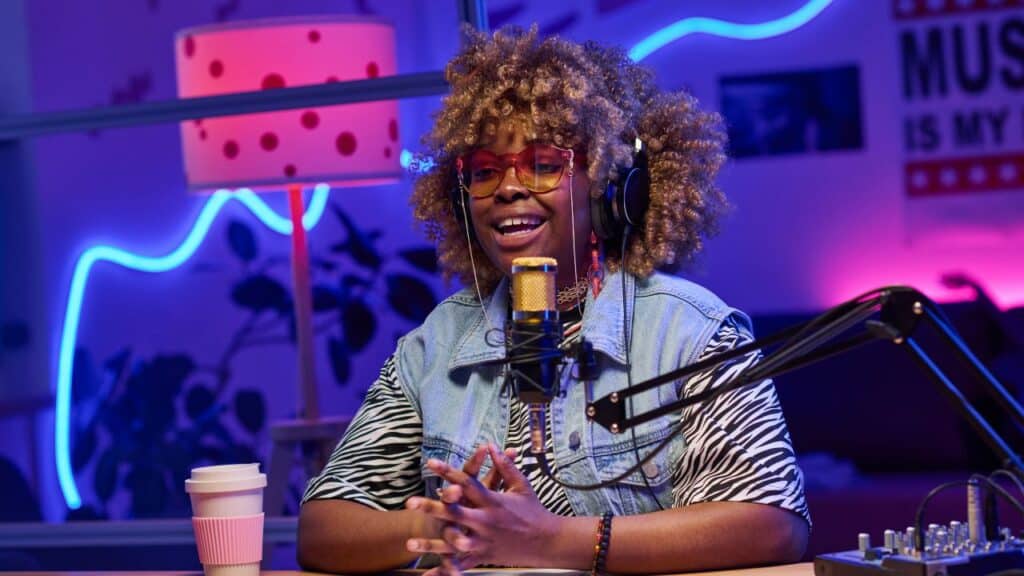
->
[449,138,650,241]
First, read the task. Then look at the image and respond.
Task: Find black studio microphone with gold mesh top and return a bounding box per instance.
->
[506,257,562,454]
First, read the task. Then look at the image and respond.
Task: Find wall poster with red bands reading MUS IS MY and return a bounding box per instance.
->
[892,0,1024,244]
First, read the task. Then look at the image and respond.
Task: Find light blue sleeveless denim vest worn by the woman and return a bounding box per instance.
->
[396,274,750,516]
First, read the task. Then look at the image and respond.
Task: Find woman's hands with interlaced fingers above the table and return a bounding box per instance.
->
[406,444,560,576]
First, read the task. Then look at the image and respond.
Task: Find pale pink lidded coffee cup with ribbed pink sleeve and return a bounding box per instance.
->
[185,463,266,576]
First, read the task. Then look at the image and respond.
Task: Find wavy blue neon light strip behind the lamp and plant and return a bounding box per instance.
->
[53,183,331,509]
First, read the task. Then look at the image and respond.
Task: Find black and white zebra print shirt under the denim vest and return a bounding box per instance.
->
[302,311,810,522]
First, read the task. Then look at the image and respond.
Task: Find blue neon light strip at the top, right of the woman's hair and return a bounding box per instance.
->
[630,0,833,61]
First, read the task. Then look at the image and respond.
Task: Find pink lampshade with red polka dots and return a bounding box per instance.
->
[175,16,401,191]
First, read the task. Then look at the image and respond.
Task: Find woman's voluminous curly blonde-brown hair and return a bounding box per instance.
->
[411,26,727,293]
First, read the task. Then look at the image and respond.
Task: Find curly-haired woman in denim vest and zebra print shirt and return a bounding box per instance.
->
[299,28,809,573]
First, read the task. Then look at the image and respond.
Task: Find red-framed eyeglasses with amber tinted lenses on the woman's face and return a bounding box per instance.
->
[456,143,574,198]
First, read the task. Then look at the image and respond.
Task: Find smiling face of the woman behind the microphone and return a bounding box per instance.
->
[464,120,591,287]
